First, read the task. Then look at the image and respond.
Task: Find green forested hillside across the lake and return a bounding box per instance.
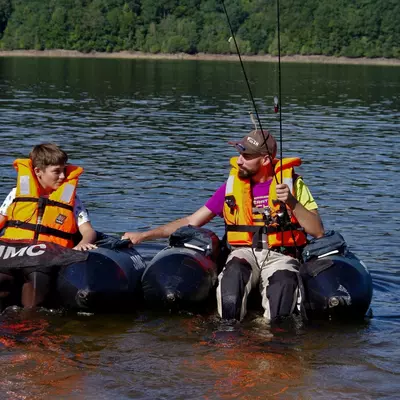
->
[0,0,400,58]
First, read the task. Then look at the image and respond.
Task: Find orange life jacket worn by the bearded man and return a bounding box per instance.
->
[223,157,307,248]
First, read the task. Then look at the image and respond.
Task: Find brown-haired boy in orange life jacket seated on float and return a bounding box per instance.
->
[0,143,96,307]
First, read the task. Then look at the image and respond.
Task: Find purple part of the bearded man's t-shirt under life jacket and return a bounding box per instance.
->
[205,179,272,217]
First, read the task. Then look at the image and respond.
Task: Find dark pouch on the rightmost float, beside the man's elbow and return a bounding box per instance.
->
[302,231,347,262]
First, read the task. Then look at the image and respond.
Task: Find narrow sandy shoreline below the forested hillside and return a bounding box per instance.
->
[0,50,400,66]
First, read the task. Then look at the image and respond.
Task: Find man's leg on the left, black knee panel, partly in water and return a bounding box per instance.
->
[217,257,258,321]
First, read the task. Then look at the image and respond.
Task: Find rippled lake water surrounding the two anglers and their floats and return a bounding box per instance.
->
[0,58,400,399]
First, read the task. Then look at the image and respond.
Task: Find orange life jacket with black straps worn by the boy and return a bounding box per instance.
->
[2,159,83,247]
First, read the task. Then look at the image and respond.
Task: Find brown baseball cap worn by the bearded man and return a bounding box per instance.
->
[229,129,277,158]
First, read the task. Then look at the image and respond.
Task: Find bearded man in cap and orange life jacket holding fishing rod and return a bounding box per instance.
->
[123,130,324,321]
